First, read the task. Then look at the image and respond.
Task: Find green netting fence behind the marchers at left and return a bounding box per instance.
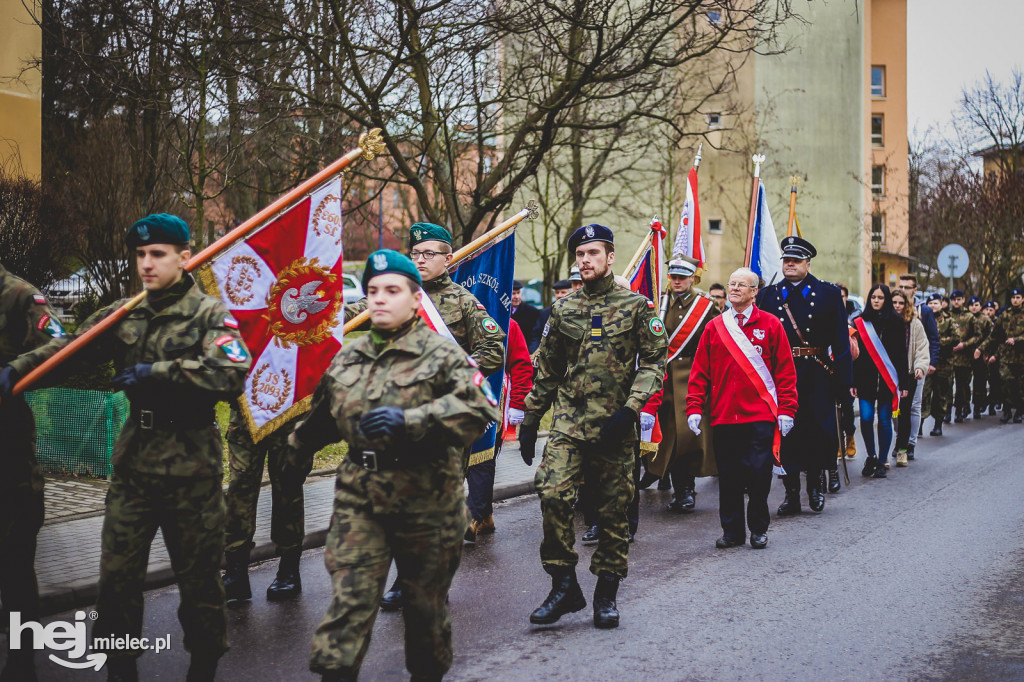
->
[25,388,128,476]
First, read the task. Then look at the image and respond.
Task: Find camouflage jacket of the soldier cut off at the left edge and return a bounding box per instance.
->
[0,265,65,495]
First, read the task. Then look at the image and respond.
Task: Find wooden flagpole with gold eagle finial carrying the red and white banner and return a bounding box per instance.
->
[12,128,384,395]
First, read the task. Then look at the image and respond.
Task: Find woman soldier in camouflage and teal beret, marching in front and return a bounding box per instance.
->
[288,250,500,680]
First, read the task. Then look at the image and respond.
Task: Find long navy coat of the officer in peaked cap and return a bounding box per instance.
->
[757,274,853,474]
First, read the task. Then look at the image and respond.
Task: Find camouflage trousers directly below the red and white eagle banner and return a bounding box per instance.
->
[224,410,305,554]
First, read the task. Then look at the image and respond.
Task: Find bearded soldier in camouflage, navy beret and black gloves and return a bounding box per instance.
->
[519,225,667,628]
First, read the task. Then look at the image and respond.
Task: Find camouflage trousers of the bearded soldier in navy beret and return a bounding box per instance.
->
[534,433,636,578]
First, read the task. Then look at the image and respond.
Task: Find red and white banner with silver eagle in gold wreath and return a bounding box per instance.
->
[198,177,344,441]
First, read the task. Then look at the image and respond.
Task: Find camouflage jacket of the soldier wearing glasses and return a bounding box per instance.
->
[345,272,505,377]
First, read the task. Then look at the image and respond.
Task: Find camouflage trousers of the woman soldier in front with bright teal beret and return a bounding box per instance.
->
[309,460,467,679]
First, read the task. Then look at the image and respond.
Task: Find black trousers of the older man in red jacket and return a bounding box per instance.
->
[714,422,775,540]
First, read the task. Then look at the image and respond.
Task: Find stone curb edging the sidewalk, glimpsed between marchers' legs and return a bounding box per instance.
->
[39,454,535,616]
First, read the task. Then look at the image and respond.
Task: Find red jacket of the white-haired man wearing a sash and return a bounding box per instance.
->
[686,305,797,426]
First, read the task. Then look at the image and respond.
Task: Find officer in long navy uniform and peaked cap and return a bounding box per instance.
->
[757,237,853,516]
